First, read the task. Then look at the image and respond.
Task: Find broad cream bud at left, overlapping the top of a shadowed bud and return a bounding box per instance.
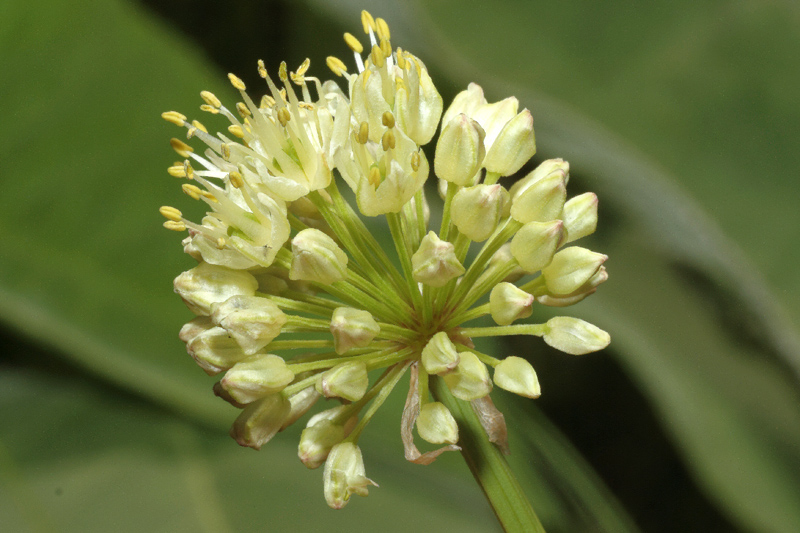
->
[211,296,286,355]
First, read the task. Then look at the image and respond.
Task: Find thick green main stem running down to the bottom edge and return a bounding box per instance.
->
[431,376,544,533]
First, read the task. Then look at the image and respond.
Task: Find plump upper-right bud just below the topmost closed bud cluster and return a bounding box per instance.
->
[510,159,569,224]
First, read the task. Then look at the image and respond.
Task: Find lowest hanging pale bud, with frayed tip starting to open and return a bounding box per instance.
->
[322,442,378,509]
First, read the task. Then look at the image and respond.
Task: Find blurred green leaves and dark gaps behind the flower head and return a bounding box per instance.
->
[0,0,800,532]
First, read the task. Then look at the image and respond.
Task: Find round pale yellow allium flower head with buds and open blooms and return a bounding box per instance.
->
[161,8,609,508]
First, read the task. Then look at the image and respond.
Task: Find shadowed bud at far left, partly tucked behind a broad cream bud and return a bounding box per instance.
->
[179,317,247,376]
